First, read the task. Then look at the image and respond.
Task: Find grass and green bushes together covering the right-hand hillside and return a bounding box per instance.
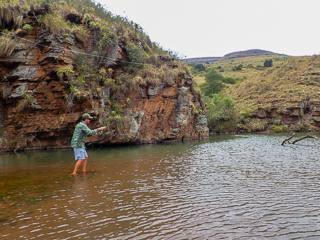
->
[189,55,320,132]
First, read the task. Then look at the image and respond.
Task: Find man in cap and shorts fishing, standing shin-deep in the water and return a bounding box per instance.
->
[71,113,106,175]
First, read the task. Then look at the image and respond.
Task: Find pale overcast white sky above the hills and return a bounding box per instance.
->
[96,0,320,58]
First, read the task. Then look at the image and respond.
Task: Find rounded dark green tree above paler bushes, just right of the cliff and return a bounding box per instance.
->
[200,69,224,96]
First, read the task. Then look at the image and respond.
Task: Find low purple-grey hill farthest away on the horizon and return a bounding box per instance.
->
[182,49,284,63]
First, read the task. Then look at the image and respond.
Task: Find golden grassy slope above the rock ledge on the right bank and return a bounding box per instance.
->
[194,55,320,109]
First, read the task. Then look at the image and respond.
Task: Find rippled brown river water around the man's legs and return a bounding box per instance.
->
[0,133,320,240]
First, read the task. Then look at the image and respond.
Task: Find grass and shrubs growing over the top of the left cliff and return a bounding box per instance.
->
[0,0,189,132]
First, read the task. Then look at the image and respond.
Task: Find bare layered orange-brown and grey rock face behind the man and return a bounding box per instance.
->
[0,11,209,151]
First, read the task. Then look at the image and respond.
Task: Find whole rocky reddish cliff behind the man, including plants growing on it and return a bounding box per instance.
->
[0,2,209,151]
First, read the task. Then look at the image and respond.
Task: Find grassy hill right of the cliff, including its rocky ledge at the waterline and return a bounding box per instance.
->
[189,55,320,132]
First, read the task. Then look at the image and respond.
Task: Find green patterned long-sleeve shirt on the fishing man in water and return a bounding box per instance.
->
[71,121,99,149]
